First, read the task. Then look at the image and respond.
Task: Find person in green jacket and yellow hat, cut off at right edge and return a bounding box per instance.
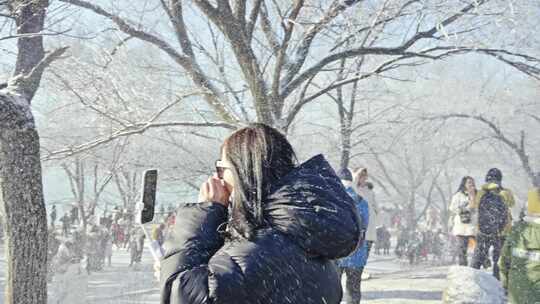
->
[499,173,540,304]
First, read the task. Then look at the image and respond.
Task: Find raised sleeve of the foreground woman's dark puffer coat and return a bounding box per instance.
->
[160,203,227,304]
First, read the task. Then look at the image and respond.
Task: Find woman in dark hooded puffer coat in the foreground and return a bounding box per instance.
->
[160,124,361,304]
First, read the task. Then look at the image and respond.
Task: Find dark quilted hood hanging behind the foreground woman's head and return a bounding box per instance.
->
[264,155,361,259]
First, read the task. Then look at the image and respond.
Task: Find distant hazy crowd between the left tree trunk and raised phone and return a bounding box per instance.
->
[48,206,176,279]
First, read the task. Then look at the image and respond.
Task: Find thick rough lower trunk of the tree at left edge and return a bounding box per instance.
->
[0,92,47,304]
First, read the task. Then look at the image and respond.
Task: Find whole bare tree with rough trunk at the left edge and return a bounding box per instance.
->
[0,0,65,304]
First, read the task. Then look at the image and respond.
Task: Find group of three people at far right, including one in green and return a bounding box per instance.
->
[450,168,540,303]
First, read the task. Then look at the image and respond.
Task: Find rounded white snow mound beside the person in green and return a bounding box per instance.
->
[443,266,506,304]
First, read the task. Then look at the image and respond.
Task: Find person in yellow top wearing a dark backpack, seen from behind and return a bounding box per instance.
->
[472,168,515,279]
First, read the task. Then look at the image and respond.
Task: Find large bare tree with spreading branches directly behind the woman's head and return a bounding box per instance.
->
[49,0,534,130]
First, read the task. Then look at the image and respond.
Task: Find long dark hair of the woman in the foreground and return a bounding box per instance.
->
[221,123,296,239]
